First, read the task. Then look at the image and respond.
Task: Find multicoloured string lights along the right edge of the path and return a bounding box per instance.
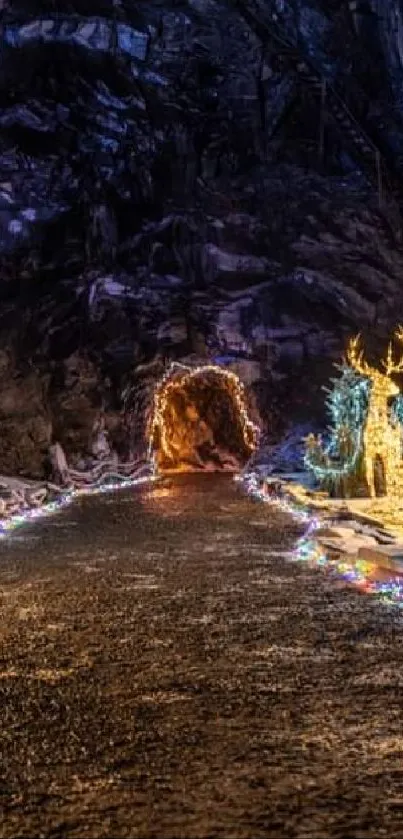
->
[235,472,403,608]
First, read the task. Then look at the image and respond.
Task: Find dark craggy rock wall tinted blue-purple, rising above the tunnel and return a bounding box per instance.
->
[0,0,403,476]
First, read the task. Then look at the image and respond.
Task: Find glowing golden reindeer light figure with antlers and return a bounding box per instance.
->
[347,326,403,497]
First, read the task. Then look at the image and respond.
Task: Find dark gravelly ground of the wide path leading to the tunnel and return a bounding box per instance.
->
[0,475,403,839]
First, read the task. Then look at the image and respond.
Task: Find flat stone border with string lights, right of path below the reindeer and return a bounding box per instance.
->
[239,472,403,608]
